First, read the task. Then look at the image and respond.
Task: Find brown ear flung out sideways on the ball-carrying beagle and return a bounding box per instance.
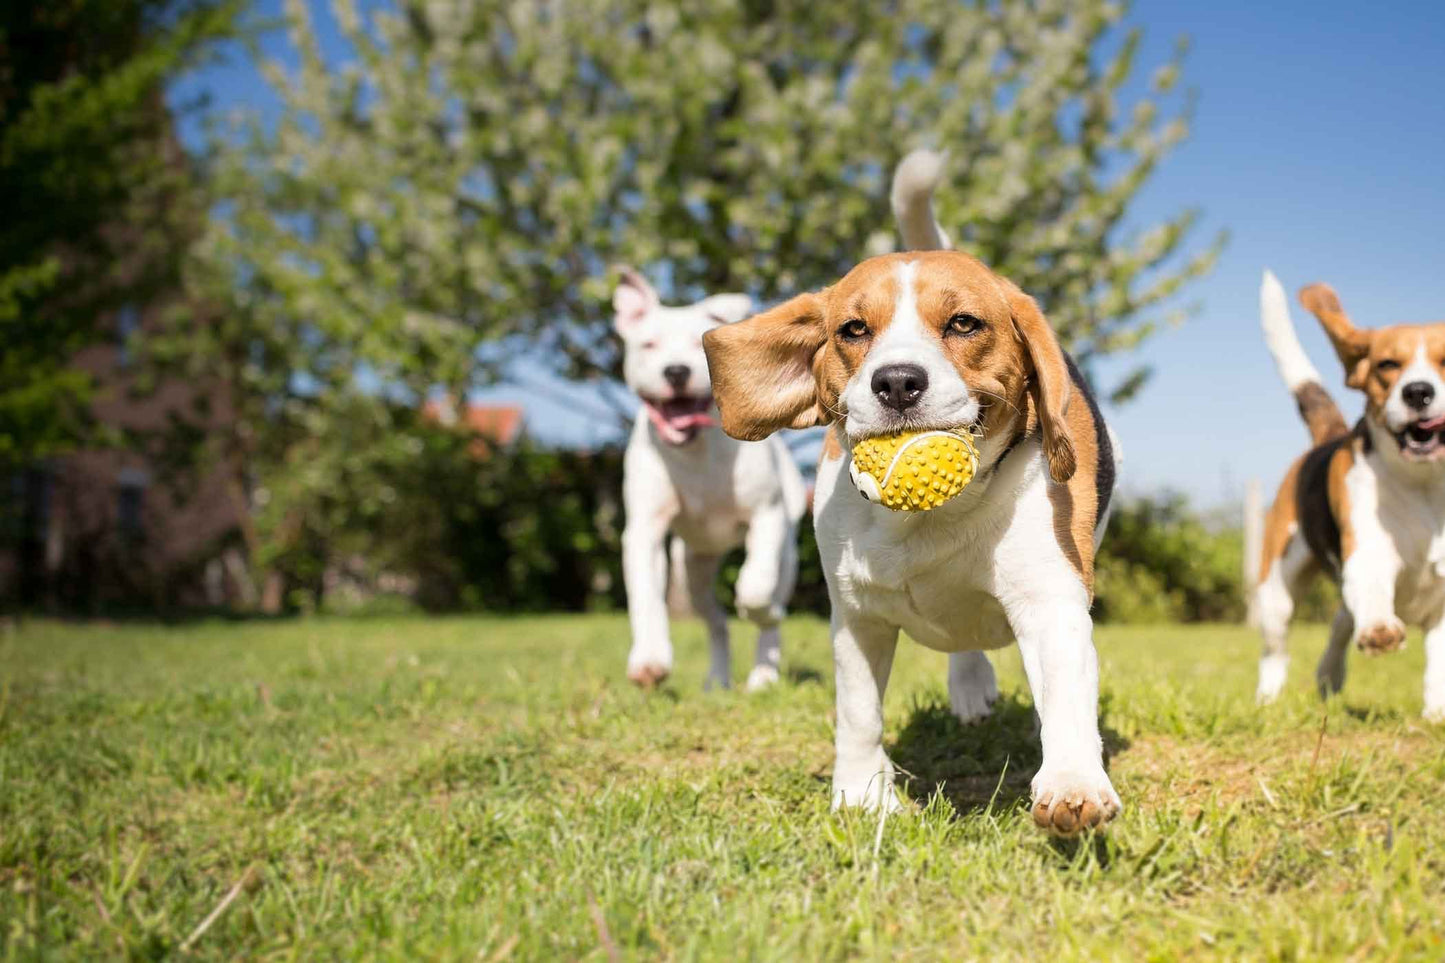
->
[702,294,828,441]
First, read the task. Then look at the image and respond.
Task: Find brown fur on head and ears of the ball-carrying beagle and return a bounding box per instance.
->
[702,252,1100,581]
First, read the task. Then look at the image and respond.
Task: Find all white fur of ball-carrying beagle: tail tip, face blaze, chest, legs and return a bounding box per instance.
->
[814,163,1123,816]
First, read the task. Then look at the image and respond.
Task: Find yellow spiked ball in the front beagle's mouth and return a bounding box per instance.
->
[848,431,978,512]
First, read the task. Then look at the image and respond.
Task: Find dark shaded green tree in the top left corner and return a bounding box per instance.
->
[0,0,241,467]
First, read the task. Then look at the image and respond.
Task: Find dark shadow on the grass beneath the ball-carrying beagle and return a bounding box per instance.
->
[889,693,1129,816]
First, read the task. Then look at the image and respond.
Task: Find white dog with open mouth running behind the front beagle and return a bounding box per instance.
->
[613,269,808,690]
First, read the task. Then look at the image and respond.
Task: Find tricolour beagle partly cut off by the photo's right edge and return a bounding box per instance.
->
[1254,272,1445,722]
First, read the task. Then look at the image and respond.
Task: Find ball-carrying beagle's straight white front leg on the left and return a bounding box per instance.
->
[832,603,900,811]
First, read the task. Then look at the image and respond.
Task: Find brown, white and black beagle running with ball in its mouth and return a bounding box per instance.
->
[702,152,1120,834]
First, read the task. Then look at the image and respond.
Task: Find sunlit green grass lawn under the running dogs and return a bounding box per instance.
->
[0,616,1445,960]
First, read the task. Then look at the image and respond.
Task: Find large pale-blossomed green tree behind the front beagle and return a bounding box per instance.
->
[177,0,1218,604]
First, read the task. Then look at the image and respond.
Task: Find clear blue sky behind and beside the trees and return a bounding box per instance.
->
[178,0,1445,506]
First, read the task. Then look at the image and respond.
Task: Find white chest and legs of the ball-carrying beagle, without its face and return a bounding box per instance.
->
[814,416,1121,813]
